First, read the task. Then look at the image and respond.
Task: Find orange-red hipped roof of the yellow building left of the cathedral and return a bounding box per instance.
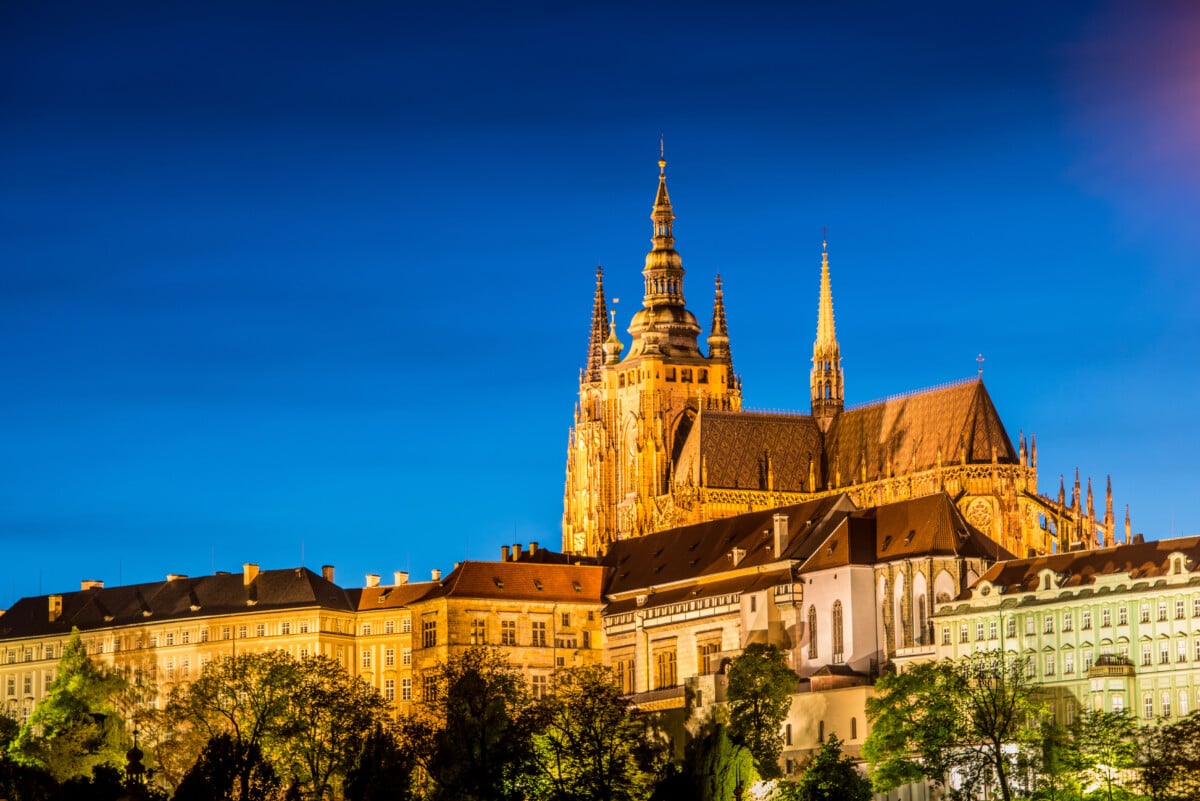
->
[425,561,606,603]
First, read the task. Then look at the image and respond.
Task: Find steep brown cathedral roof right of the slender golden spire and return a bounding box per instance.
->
[826,379,1018,481]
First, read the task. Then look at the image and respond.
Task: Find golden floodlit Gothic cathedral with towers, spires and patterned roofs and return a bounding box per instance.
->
[563,157,1113,556]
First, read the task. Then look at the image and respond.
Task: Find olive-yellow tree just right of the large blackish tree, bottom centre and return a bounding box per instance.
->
[535,666,653,801]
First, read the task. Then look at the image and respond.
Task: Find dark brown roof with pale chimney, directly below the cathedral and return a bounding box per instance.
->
[602,495,854,595]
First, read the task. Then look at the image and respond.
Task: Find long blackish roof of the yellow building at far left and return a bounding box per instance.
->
[0,567,354,638]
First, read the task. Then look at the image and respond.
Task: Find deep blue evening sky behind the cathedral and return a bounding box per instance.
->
[0,1,1200,608]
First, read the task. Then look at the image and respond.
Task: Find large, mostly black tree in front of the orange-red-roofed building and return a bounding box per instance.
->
[400,648,536,801]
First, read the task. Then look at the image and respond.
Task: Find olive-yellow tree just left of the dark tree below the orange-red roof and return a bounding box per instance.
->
[269,656,388,799]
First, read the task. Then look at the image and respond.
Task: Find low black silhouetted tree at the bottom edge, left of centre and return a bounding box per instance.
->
[174,733,281,801]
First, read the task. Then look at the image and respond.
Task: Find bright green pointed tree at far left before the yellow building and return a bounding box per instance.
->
[11,630,127,782]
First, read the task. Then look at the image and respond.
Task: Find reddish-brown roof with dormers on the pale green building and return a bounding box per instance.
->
[962,536,1200,598]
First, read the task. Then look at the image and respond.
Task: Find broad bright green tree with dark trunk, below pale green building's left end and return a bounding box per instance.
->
[863,651,1042,801]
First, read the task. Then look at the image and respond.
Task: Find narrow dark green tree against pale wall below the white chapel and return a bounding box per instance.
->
[726,643,799,778]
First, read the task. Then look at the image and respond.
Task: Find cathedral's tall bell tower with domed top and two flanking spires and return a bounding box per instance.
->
[563,153,742,554]
